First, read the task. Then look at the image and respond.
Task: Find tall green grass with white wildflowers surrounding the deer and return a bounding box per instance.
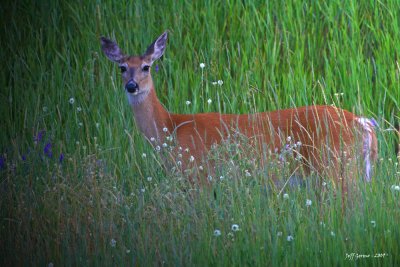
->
[0,0,400,266]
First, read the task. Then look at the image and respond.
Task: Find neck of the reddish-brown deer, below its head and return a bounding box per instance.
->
[129,83,171,142]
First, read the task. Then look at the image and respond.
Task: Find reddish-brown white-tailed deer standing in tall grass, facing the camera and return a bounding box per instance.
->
[101,32,377,189]
